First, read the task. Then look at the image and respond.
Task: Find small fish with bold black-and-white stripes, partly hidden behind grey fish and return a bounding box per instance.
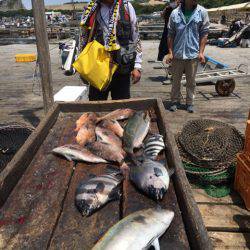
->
[143,134,165,160]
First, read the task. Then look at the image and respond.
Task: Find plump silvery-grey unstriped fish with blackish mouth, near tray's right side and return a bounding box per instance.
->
[129,158,172,201]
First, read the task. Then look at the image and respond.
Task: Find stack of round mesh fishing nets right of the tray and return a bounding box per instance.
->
[176,120,244,198]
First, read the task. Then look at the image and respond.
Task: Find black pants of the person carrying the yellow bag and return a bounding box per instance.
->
[89,74,130,101]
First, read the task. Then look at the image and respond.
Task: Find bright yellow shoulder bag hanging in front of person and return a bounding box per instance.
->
[73,40,118,91]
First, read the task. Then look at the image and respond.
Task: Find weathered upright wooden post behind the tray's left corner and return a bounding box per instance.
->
[32,0,54,113]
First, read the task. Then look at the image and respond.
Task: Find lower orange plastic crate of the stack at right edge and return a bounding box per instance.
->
[234,153,250,210]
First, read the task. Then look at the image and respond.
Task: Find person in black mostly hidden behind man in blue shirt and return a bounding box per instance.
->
[157,0,180,61]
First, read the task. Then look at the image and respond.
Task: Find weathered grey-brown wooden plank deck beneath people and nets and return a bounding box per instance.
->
[0,41,250,249]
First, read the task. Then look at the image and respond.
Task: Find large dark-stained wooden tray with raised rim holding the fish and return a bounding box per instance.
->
[0,99,212,250]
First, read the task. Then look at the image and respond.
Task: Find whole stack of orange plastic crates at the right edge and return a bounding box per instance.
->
[235,113,250,210]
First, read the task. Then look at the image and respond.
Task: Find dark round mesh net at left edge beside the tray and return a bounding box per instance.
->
[0,123,34,172]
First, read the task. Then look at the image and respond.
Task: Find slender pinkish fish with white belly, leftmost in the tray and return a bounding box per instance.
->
[52,144,107,163]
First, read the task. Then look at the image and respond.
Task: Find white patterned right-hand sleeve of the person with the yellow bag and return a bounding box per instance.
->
[128,3,142,69]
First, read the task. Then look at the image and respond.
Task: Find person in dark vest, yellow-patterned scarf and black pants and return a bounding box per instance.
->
[81,0,142,101]
